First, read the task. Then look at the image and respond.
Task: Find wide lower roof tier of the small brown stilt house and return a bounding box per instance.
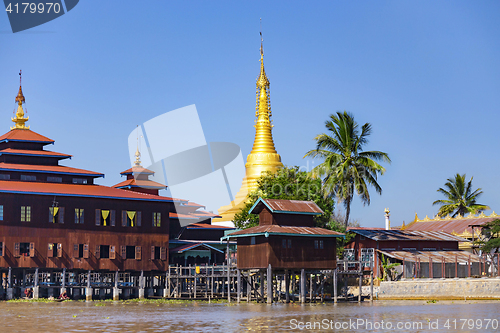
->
[221,224,344,240]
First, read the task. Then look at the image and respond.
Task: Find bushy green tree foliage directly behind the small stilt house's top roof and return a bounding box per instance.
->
[234,166,334,229]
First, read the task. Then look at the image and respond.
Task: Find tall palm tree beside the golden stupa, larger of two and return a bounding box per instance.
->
[304,111,391,227]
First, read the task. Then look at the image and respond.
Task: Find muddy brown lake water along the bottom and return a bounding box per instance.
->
[0,301,500,333]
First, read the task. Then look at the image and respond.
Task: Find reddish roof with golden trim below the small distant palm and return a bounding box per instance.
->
[404,217,498,235]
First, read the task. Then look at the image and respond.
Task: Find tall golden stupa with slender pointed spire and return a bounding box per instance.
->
[217,40,283,223]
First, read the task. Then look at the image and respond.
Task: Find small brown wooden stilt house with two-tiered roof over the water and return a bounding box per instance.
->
[222,198,343,270]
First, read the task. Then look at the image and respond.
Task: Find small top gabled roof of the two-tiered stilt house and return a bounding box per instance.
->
[249,198,323,215]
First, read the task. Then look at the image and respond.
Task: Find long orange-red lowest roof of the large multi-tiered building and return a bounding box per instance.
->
[0,180,176,202]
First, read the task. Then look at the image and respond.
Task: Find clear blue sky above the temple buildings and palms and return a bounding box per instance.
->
[0,0,500,226]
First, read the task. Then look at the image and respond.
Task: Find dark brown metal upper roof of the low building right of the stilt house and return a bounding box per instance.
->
[349,228,467,242]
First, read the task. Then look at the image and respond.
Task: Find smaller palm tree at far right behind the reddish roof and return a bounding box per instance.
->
[432,173,490,217]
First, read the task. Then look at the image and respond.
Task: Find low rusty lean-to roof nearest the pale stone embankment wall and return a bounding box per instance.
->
[377,250,481,263]
